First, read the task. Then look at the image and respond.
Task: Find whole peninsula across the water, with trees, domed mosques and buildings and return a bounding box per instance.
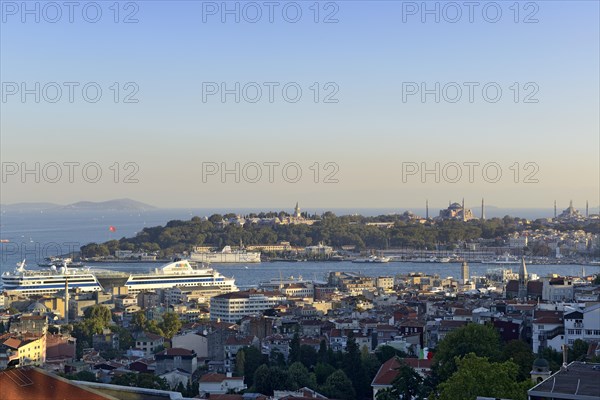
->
[81,203,600,258]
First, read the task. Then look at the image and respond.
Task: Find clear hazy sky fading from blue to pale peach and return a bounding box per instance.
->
[0,1,600,208]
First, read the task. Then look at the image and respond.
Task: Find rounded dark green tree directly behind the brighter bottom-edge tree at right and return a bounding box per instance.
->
[432,323,500,381]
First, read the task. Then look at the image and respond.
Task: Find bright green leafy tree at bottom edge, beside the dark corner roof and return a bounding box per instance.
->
[438,353,531,400]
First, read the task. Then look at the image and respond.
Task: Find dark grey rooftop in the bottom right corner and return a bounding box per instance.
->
[528,361,600,400]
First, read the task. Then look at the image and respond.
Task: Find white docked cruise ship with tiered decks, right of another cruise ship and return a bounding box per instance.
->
[123,260,238,294]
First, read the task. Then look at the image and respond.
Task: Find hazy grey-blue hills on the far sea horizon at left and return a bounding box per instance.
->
[0,199,156,212]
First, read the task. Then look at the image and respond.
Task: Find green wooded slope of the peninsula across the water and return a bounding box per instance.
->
[81,212,534,257]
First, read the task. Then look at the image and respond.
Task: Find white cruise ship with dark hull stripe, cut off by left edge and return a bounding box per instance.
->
[2,260,102,296]
